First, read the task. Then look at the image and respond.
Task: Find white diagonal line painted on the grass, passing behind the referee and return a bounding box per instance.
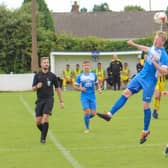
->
[20,95,82,168]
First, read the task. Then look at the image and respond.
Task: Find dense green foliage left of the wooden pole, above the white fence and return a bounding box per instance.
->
[0,4,31,73]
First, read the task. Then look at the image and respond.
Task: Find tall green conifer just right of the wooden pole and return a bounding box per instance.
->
[24,0,56,62]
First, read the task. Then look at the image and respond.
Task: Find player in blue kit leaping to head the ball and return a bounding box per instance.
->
[97,31,168,144]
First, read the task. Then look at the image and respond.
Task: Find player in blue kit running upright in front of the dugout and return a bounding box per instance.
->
[75,61,101,133]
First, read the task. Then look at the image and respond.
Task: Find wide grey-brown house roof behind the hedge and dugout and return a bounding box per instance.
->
[53,11,163,39]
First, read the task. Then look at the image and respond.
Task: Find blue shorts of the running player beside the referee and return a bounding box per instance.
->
[81,95,96,110]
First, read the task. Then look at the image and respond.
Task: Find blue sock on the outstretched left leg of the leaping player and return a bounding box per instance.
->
[110,95,128,115]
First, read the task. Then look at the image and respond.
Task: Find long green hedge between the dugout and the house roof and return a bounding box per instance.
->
[54,34,156,51]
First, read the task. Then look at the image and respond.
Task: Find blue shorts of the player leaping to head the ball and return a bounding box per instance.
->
[127,76,156,103]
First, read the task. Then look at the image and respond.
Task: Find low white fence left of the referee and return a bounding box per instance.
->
[0,74,34,91]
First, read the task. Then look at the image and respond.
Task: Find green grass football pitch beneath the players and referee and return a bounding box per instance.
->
[0,90,168,168]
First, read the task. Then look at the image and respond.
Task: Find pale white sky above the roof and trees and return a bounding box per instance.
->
[0,0,168,12]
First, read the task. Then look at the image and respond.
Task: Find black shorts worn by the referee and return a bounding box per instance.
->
[35,97,54,117]
